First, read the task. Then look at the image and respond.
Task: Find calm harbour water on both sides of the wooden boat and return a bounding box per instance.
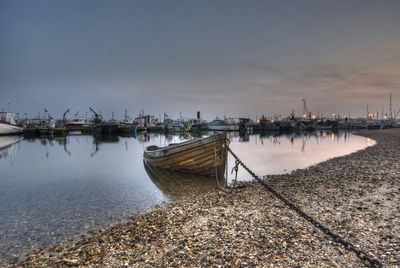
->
[0,132,374,258]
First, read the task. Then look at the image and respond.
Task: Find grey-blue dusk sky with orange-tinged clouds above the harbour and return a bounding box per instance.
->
[0,0,400,119]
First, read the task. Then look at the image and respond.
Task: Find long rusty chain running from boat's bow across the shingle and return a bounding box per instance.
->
[226,146,383,268]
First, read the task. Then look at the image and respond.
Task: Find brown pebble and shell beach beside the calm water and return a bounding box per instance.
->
[10,129,400,267]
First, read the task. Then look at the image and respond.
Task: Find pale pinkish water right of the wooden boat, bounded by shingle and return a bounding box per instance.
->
[229,131,375,180]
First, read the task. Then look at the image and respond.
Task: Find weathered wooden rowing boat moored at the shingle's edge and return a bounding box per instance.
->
[143,133,228,178]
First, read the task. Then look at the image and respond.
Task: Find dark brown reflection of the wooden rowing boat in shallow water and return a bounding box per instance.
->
[144,164,220,199]
